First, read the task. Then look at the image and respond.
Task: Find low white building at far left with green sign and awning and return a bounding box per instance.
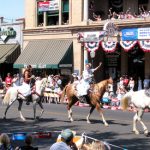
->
[0,17,24,79]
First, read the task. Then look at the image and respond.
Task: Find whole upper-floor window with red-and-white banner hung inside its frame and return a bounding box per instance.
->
[37,0,69,26]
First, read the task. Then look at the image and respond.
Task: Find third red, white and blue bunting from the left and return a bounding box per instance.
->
[120,41,137,52]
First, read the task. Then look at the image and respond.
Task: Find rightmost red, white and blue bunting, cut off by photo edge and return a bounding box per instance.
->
[138,40,150,52]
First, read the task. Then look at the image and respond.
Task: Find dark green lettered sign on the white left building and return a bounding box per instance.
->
[0,27,16,42]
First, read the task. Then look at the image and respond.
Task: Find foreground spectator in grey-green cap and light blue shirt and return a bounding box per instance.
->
[50,129,78,150]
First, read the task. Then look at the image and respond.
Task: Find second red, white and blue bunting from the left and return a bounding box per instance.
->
[101,41,117,53]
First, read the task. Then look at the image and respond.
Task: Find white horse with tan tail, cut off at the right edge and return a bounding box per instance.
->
[121,90,150,136]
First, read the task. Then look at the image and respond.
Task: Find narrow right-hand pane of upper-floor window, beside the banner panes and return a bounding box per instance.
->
[62,0,69,24]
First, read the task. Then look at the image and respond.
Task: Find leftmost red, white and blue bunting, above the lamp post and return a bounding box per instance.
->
[84,42,99,52]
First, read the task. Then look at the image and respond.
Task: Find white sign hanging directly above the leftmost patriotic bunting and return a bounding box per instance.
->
[77,31,105,43]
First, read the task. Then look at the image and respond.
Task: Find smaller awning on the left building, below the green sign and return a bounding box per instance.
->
[0,44,20,63]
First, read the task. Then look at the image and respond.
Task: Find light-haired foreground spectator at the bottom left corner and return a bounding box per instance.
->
[0,133,13,150]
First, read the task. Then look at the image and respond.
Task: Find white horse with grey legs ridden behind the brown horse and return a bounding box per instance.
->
[2,78,47,121]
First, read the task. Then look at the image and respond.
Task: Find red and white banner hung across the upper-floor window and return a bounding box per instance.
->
[38,0,59,12]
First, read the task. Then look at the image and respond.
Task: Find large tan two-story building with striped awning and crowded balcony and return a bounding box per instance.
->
[14,0,150,81]
